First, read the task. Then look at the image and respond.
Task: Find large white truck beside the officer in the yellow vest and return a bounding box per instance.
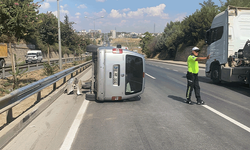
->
[206,6,250,84]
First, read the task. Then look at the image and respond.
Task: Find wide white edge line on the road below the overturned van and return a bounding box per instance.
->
[60,100,89,150]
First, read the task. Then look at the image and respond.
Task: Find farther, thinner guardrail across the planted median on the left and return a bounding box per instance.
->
[0,57,85,79]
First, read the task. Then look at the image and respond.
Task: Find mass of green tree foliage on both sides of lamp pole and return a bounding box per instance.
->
[0,0,92,56]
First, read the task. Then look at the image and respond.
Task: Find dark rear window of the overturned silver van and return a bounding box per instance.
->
[125,55,143,95]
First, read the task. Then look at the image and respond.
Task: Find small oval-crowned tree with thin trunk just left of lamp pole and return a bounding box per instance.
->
[39,12,58,64]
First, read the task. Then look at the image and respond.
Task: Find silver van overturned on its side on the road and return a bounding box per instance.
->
[86,45,145,101]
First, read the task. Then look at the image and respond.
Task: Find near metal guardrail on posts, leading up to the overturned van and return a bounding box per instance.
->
[0,61,92,123]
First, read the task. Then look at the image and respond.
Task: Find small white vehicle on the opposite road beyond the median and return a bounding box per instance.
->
[25,50,43,63]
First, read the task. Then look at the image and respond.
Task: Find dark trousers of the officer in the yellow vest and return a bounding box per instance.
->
[186,72,201,101]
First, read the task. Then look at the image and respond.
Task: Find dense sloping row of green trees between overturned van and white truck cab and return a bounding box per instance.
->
[141,0,220,58]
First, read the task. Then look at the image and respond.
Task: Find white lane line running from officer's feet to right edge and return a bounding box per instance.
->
[202,105,250,132]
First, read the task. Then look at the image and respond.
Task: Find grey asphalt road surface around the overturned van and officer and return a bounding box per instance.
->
[2,61,250,150]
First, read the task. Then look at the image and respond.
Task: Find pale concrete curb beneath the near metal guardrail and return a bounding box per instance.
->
[0,67,91,149]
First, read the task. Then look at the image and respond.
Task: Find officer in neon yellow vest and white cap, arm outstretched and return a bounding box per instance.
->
[186,47,210,105]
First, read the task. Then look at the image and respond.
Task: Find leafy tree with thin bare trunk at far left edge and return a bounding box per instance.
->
[0,0,40,89]
